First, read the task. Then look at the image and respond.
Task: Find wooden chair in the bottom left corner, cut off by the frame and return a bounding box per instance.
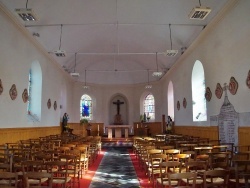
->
[0,172,18,188]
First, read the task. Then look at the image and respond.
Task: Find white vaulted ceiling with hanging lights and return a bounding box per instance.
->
[0,0,228,84]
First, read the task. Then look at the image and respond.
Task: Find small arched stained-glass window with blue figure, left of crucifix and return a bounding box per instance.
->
[80,94,92,120]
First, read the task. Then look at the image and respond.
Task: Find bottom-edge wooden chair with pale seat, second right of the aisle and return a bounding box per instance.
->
[203,170,229,188]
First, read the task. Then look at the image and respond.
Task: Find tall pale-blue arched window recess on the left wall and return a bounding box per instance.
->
[27,61,42,120]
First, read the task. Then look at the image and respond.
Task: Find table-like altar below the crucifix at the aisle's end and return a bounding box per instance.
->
[105,125,133,138]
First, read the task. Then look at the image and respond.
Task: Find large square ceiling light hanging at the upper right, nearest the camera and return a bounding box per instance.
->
[188,0,211,20]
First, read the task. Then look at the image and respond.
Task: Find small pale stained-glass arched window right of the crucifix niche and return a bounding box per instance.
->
[144,94,155,120]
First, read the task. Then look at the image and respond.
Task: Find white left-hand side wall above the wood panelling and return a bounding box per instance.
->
[0,6,72,128]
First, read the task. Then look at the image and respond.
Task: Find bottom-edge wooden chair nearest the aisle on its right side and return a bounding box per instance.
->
[168,172,197,188]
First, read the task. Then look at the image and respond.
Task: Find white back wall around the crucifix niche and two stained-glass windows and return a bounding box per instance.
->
[71,82,162,125]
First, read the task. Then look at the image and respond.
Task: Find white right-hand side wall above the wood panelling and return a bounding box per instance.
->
[160,0,250,125]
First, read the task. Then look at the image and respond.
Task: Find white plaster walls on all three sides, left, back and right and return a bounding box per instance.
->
[0,0,250,128]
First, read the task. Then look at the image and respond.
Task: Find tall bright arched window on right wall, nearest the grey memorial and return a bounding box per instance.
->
[192,60,207,121]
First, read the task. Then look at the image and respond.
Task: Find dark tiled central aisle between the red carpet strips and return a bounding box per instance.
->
[89,147,140,188]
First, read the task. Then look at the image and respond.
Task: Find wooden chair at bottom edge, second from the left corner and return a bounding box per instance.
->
[24,172,53,188]
